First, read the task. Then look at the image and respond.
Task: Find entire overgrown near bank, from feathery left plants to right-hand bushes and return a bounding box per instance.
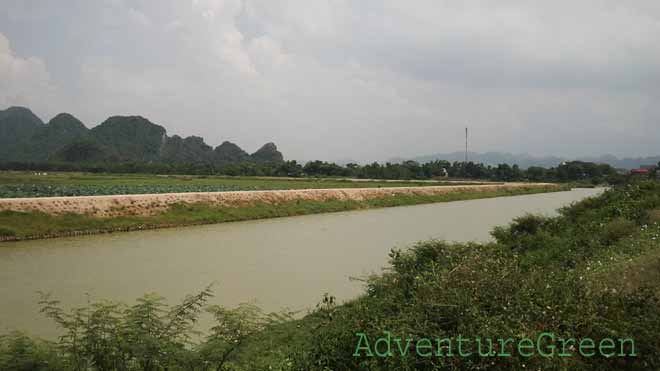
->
[0,182,660,370]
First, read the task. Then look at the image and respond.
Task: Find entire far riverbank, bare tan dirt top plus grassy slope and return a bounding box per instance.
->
[0,183,564,241]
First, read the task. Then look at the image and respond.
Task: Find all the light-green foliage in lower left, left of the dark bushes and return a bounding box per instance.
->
[0,288,291,370]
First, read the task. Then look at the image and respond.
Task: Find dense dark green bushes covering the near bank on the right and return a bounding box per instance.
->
[294,182,660,370]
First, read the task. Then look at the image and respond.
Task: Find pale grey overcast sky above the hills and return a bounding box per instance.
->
[0,0,660,162]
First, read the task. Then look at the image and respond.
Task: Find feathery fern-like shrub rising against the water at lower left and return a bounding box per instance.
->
[40,286,212,370]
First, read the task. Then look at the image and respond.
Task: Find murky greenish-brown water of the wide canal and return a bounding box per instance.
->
[0,189,601,338]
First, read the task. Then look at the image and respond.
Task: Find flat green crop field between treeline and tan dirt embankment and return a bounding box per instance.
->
[0,171,474,198]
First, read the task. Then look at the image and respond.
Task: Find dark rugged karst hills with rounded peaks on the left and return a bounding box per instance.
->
[0,107,284,165]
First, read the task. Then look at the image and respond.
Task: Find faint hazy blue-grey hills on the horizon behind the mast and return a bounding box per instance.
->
[390,152,660,169]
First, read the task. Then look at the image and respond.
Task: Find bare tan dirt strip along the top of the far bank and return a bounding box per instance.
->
[0,183,557,217]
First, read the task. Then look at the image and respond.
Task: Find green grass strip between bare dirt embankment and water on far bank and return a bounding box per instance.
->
[0,187,565,240]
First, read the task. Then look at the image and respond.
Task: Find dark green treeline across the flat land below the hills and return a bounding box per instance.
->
[0,160,655,184]
